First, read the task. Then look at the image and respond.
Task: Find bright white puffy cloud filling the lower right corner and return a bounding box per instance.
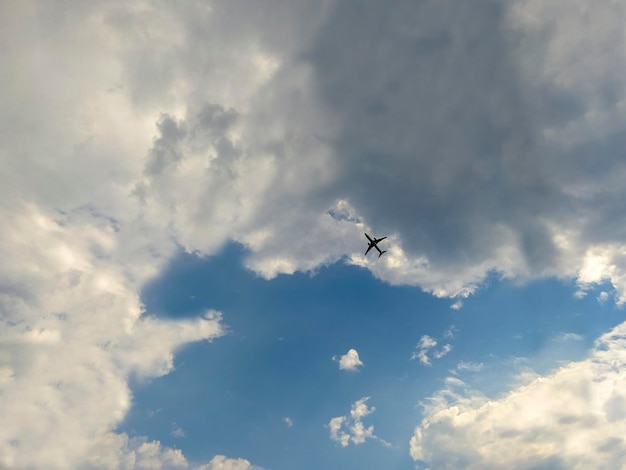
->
[411,324,626,469]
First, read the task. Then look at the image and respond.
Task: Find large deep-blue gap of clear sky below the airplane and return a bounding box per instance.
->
[120,244,624,469]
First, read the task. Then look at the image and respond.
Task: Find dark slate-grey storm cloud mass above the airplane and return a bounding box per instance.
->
[302,0,556,270]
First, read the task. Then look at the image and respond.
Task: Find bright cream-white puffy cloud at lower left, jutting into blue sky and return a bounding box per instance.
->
[0,203,223,468]
